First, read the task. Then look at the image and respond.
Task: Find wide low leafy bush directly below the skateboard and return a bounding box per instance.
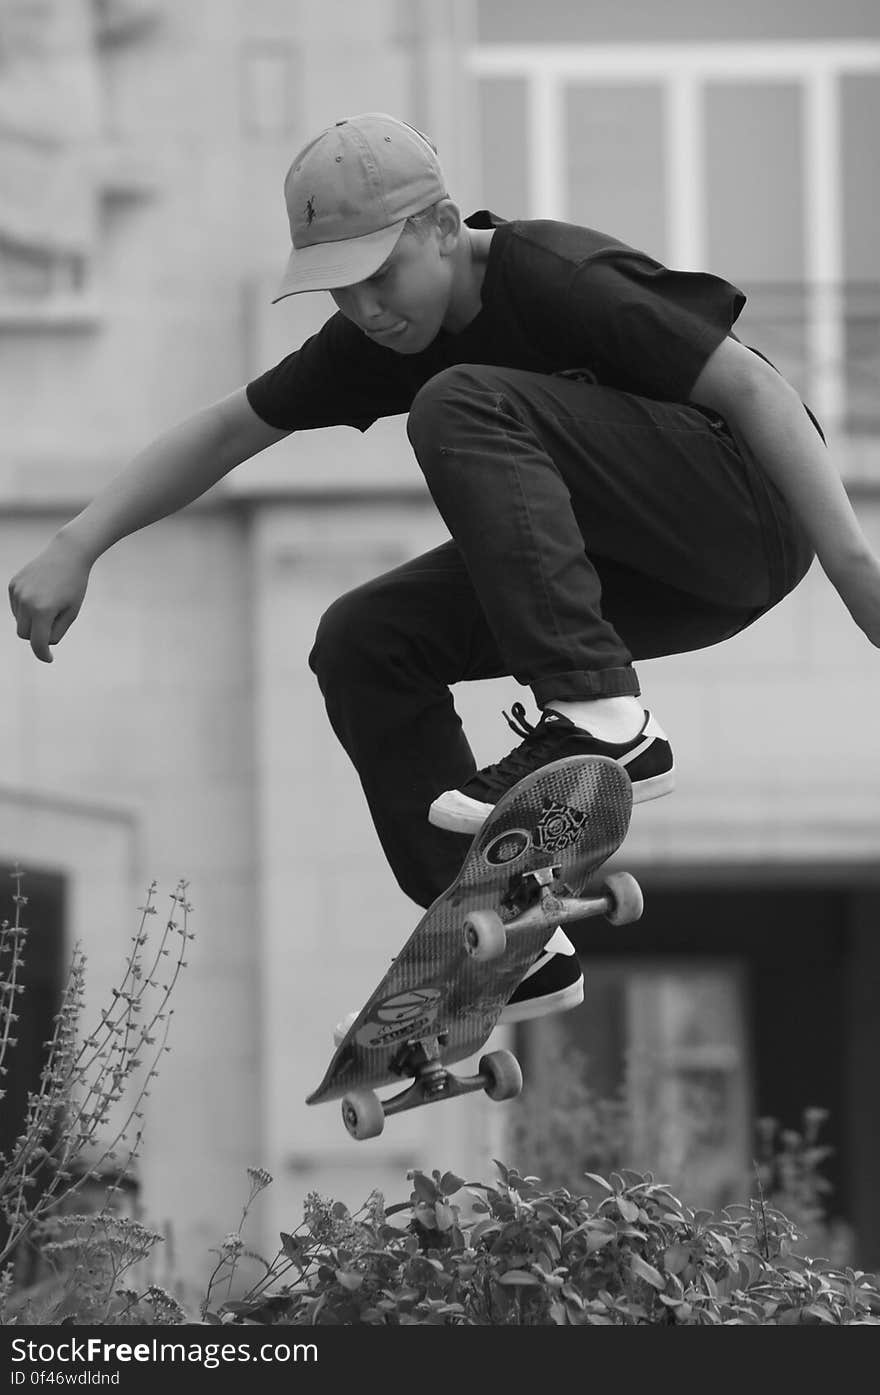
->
[196,1163,880,1327]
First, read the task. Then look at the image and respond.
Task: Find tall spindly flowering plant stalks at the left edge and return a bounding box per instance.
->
[0,869,192,1321]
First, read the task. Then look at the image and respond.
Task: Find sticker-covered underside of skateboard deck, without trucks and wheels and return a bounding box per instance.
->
[307,756,632,1105]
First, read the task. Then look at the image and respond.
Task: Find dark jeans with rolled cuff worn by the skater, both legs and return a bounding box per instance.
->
[310,365,812,905]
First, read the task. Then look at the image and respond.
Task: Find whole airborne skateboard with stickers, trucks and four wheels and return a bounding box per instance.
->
[305,756,642,1140]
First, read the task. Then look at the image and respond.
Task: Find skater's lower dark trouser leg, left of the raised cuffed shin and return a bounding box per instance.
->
[310,543,505,905]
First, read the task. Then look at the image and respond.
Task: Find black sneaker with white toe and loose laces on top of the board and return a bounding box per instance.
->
[428,702,675,833]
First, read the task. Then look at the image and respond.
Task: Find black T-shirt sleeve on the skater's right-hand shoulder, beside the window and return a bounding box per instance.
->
[566,251,746,402]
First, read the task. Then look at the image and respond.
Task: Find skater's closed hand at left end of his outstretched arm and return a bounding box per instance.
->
[10,533,91,664]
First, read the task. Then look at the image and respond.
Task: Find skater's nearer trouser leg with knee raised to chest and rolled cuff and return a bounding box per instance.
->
[409,365,809,704]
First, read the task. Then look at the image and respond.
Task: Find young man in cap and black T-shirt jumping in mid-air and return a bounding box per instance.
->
[10,113,880,1020]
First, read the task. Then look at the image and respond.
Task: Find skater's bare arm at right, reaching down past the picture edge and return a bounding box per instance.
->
[690,339,880,647]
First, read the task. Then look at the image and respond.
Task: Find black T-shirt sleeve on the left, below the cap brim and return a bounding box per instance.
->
[245,312,409,431]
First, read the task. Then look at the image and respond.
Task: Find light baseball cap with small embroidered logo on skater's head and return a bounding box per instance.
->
[272,112,446,304]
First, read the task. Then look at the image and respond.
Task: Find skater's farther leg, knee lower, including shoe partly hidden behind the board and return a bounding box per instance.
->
[311,532,749,1042]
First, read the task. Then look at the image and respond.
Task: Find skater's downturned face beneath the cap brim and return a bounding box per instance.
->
[331,227,455,353]
